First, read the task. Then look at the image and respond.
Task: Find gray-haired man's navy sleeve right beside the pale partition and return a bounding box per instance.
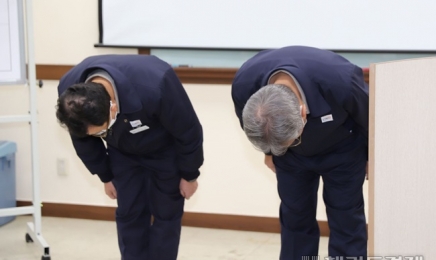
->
[344,66,369,140]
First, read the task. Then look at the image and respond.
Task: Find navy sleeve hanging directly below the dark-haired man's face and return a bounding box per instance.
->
[71,136,114,183]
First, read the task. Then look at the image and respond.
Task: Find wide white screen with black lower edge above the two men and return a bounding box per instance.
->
[100,0,436,52]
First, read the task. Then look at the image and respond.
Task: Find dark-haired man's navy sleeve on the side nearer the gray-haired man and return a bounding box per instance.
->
[159,69,203,181]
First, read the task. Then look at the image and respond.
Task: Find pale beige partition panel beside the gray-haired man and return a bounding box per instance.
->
[369,58,436,260]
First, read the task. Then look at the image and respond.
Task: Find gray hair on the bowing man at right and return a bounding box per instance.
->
[242,84,304,156]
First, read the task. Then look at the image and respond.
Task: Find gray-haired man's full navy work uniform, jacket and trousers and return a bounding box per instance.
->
[232,46,369,260]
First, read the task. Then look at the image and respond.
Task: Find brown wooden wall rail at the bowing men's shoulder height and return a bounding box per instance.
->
[36,64,369,84]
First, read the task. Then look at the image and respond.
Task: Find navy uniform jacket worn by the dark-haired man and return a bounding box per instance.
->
[58,55,203,182]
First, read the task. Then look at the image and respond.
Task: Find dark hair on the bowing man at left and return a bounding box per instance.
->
[56,82,110,137]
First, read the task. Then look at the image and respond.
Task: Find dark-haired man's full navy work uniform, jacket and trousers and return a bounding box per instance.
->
[58,55,203,260]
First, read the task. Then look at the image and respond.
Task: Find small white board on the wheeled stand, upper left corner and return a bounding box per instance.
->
[0,0,26,85]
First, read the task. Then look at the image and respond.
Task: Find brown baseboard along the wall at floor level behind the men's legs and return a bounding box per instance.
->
[17,201,330,236]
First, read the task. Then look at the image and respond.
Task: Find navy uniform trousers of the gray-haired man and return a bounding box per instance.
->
[273,137,367,260]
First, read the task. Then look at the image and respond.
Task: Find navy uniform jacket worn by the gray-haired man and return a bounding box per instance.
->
[232,46,369,156]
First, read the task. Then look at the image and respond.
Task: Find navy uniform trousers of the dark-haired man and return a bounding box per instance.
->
[108,148,184,260]
